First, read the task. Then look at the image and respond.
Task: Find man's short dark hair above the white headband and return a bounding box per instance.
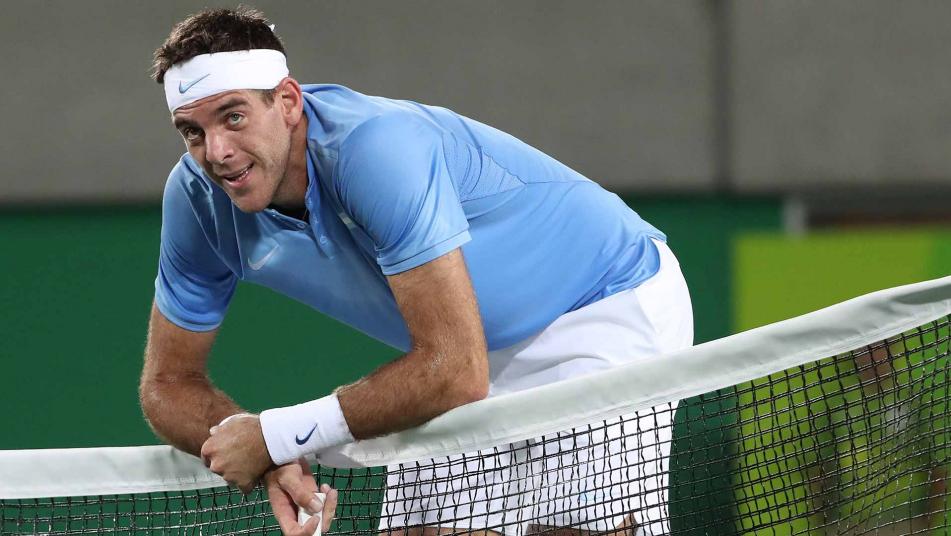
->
[152,6,284,84]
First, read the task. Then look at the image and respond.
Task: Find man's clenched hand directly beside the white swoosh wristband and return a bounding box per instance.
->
[201,414,272,494]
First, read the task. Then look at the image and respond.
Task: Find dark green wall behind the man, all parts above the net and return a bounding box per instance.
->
[0,197,779,449]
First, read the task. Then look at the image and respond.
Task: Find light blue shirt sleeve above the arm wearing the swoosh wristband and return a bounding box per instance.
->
[334,112,470,275]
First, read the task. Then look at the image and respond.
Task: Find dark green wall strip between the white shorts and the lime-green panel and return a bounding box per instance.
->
[628,196,781,536]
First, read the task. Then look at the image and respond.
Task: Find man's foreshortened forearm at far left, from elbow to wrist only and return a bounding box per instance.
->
[139,376,243,456]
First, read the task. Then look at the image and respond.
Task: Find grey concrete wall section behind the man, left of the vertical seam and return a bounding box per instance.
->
[0,0,712,202]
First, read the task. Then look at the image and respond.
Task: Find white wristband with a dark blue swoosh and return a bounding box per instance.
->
[261,394,353,465]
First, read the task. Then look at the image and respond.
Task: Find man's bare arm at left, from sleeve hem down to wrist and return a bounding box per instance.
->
[139,304,242,456]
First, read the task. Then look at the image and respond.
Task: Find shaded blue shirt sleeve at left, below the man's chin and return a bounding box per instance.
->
[155,163,237,331]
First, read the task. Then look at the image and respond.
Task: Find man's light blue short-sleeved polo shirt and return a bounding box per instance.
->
[155,85,665,351]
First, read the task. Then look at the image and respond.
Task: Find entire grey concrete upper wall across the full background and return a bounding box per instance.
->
[0,0,951,205]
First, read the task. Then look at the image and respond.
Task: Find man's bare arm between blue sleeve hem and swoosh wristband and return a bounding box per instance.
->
[337,249,489,439]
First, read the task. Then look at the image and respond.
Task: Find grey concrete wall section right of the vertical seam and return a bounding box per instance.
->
[730,0,951,190]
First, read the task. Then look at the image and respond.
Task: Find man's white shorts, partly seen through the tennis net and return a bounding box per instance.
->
[380,241,693,536]
